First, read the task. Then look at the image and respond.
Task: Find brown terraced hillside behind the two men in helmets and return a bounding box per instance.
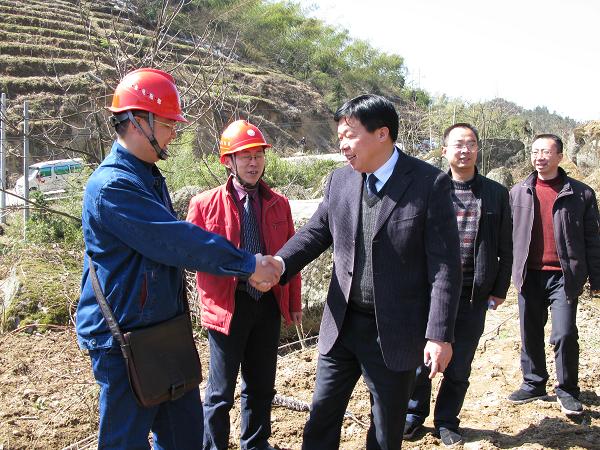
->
[0,0,333,178]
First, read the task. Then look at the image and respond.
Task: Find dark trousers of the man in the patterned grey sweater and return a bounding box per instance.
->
[406,297,487,431]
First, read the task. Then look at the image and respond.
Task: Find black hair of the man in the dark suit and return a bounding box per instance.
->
[333,94,398,142]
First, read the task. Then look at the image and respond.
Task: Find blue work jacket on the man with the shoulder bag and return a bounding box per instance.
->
[77,142,255,349]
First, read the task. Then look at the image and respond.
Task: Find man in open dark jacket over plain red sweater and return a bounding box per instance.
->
[508,134,600,415]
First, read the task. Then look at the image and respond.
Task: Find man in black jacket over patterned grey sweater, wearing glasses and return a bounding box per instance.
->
[404,123,512,446]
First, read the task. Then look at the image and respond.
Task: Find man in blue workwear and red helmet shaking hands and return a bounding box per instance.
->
[77,69,279,449]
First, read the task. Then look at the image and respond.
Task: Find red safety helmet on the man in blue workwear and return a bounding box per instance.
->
[108,68,187,123]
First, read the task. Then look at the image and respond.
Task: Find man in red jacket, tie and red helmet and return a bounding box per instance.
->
[187,120,302,450]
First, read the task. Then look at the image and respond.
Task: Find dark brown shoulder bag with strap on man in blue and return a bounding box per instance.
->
[88,256,202,408]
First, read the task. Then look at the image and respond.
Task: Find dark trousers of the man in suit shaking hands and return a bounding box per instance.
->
[302,310,415,450]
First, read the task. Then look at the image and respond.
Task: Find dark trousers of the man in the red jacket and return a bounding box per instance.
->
[204,291,281,450]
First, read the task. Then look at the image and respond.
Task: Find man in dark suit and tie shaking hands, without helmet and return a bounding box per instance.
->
[276,95,461,450]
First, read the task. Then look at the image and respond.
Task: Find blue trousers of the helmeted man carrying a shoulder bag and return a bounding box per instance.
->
[90,347,202,450]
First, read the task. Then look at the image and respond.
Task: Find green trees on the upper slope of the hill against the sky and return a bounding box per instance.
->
[135,0,420,109]
